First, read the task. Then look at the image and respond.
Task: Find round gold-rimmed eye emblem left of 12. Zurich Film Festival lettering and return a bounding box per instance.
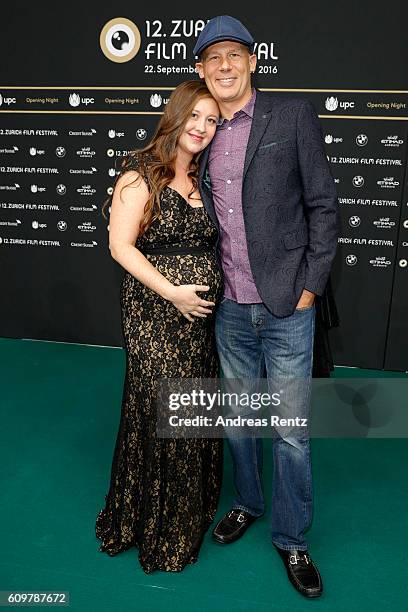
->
[99,17,142,63]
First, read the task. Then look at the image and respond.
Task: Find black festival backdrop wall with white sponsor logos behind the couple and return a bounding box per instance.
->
[0,0,408,370]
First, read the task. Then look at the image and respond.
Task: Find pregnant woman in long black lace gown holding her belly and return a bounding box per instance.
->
[96,81,222,573]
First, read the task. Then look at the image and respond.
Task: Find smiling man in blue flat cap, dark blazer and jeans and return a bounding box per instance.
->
[194,15,338,597]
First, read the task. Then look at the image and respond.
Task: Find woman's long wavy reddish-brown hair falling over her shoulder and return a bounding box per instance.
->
[102,81,218,236]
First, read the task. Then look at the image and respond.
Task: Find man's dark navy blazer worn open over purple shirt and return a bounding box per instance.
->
[199,91,339,317]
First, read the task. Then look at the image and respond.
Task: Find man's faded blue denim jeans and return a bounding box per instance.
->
[216,298,315,550]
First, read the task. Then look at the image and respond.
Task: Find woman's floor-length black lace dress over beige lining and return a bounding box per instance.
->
[96,165,222,573]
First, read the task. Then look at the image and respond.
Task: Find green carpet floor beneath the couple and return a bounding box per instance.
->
[0,339,408,612]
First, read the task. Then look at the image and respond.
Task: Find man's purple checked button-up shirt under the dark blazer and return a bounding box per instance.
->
[208,89,262,304]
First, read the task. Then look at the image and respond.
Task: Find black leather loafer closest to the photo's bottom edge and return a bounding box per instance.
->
[274,545,323,597]
